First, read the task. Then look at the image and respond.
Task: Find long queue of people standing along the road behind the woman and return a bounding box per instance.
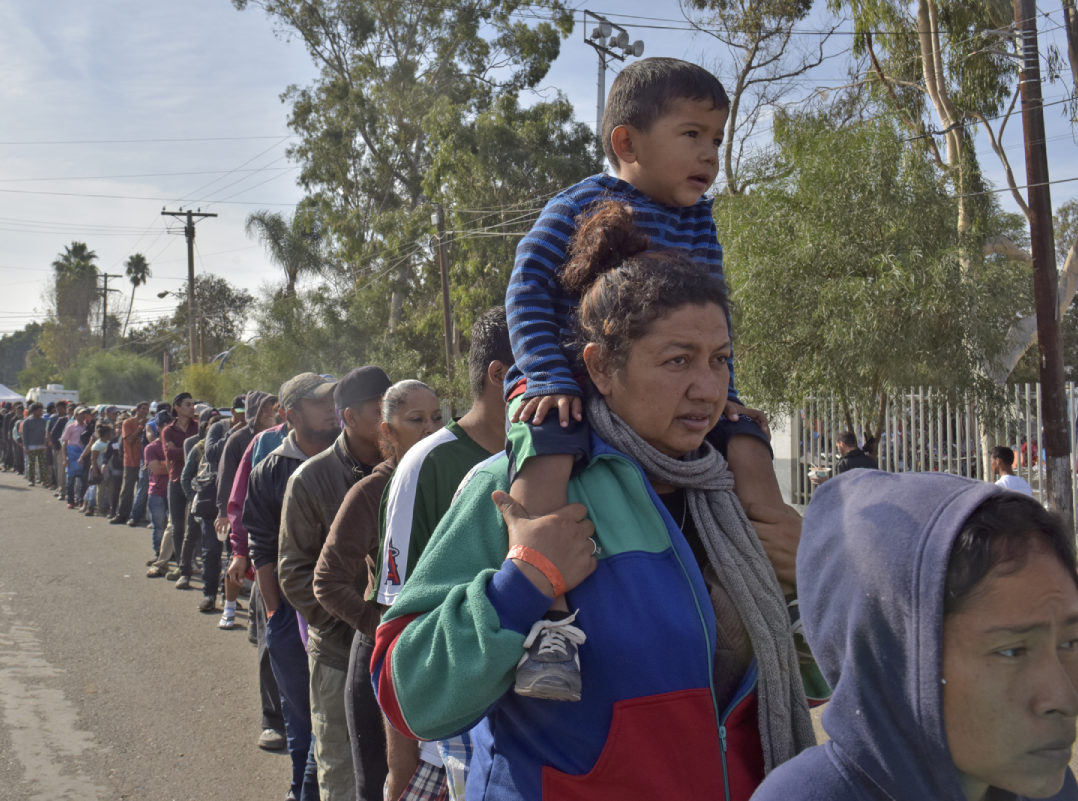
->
[3,307,512,801]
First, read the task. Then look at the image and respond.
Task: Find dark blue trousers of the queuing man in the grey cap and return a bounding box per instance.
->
[266,596,318,799]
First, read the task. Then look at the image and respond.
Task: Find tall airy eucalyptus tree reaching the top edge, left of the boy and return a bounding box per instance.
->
[233,0,594,332]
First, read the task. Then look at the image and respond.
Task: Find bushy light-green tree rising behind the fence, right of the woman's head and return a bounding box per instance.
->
[718,113,1021,433]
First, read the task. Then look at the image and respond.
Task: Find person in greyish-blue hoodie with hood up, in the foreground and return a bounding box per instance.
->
[752,470,1078,801]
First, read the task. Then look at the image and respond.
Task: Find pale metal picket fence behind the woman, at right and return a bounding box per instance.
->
[790,383,1078,505]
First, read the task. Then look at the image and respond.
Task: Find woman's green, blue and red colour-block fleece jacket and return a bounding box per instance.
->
[372,434,776,801]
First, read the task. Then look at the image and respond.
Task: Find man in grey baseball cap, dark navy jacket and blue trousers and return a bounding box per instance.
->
[243,373,341,799]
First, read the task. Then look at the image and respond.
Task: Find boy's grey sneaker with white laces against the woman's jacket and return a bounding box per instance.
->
[513,612,586,701]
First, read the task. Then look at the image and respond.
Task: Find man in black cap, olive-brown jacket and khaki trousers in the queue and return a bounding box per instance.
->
[277,365,390,801]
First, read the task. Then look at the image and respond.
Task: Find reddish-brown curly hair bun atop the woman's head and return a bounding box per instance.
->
[562,201,649,294]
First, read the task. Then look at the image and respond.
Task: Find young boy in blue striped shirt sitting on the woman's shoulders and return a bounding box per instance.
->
[506,58,801,701]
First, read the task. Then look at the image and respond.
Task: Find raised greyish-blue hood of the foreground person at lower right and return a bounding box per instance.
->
[797,470,1004,801]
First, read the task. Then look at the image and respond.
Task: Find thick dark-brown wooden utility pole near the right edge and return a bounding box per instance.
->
[1013,0,1074,533]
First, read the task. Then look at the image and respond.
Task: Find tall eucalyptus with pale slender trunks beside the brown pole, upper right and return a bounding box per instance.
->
[828,0,1078,385]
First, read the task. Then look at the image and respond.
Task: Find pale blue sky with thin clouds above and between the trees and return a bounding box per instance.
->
[0,0,1078,334]
